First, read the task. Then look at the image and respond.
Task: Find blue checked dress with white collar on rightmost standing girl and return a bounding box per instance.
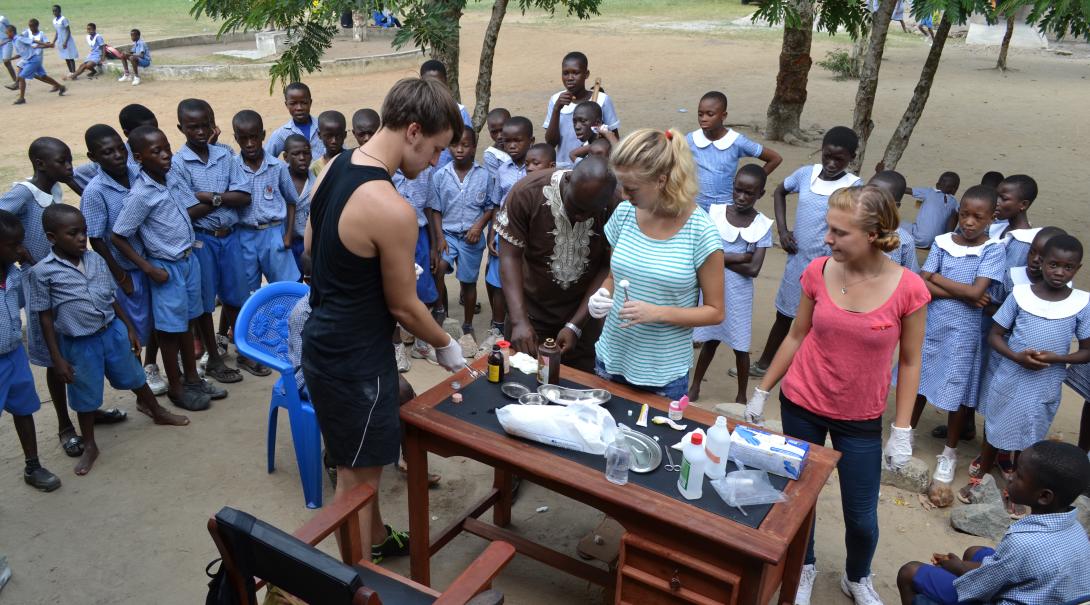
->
[983,285,1090,451]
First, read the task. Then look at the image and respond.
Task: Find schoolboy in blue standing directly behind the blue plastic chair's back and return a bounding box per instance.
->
[231,109,299,293]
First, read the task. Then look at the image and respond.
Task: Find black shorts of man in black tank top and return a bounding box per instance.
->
[303,358,401,468]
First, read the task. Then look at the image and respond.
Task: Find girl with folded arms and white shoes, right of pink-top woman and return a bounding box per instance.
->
[912,185,1006,483]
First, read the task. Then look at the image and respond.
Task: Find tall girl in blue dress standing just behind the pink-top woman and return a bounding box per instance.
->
[750,126,862,376]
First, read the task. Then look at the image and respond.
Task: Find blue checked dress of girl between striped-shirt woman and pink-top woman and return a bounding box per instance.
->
[692,204,773,352]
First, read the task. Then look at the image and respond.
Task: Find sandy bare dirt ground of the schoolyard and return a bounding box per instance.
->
[0,13,1090,605]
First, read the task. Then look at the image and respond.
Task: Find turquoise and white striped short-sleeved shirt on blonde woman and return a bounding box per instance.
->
[595,202,723,387]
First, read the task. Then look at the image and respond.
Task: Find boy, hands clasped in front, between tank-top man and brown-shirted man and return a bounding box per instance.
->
[432,126,493,359]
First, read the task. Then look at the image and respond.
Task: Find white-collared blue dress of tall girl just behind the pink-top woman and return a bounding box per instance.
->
[776,164,862,317]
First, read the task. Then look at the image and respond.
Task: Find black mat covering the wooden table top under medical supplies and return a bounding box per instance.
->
[436,370,788,529]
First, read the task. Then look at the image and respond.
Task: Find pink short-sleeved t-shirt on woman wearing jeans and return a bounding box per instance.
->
[782,256,931,420]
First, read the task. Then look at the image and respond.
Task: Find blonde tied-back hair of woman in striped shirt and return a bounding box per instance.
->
[609,129,699,216]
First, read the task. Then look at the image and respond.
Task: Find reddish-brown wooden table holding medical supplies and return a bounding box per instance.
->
[401,359,839,605]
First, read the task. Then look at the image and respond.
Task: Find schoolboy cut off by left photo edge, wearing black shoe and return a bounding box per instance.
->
[0,210,61,492]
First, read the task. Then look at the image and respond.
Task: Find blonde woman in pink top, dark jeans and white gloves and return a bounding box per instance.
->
[746,186,931,605]
